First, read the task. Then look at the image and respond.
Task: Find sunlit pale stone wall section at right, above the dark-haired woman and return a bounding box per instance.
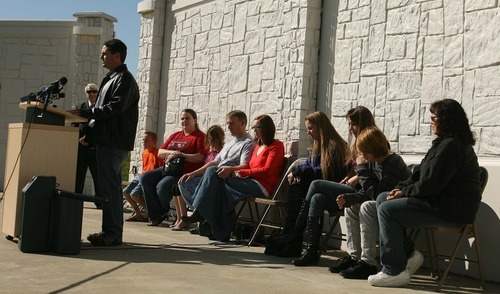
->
[332,0,500,156]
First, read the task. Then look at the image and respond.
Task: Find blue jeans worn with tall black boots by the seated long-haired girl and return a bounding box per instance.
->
[306,180,356,217]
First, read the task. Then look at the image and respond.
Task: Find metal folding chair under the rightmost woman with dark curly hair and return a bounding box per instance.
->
[415,166,488,292]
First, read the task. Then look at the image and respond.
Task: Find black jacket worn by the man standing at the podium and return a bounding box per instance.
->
[80,64,139,150]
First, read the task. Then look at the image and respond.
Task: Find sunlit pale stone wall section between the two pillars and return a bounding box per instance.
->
[138,0,321,158]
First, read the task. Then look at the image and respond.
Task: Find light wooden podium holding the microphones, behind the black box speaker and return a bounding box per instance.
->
[2,102,87,237]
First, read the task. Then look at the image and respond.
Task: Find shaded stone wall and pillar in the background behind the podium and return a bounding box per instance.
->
[0,12,116,191]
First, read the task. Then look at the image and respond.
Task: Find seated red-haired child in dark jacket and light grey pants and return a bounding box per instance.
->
[329,127,411,279]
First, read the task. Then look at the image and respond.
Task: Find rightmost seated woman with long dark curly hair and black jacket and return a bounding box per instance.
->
[368,99,481,287]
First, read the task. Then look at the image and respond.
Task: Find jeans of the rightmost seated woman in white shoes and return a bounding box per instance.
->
[377,192,456,276]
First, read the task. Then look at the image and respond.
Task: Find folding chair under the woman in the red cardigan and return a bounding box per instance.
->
[248,157,306,246]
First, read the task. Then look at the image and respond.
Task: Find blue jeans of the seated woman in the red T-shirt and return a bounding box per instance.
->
[140,167,180,221]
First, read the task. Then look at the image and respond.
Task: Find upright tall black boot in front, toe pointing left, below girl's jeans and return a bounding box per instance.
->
[292,217,322,266]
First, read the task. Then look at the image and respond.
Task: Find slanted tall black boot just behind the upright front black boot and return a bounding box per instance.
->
[275,200,309,257]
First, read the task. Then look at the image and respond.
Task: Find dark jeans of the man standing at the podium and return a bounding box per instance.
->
[96,145,128,238]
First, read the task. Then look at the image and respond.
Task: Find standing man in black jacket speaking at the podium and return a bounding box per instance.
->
[79,39,139,246]
